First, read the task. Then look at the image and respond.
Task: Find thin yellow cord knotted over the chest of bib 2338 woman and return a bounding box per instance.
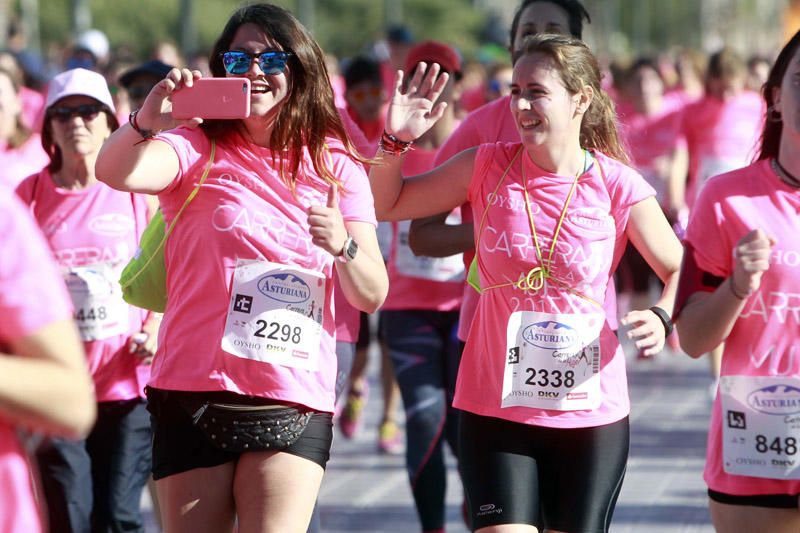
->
[475,147,603,309]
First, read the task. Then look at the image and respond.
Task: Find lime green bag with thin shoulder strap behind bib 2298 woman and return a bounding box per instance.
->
[119,140,216,313]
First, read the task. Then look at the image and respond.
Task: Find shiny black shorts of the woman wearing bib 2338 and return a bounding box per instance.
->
[459,412,630,533]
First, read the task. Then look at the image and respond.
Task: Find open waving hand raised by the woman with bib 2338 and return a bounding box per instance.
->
[386,63,450,141]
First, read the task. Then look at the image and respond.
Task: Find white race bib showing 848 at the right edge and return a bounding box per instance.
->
[719,376,800,479]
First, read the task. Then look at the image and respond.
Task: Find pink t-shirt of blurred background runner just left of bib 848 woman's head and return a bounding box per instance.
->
[683,91,766,208]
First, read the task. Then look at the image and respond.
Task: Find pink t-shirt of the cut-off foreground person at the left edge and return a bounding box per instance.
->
[0,187,72,533]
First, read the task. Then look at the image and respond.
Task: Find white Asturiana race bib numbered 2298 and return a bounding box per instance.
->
[222,259,325,371]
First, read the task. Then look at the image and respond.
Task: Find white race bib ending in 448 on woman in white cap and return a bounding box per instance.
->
[64,263,128,341]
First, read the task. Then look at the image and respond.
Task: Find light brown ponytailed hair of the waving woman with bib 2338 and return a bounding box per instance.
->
[520,33,629,163]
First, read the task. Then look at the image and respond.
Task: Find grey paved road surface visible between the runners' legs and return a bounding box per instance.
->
[146,342,713,533]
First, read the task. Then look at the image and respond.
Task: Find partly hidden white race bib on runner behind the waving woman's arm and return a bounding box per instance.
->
[394,213,464,282]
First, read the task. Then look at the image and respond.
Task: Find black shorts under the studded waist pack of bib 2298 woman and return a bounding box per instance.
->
[147,387,333,479]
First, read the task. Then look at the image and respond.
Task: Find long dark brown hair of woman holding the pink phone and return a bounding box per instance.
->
[202,4,368,189]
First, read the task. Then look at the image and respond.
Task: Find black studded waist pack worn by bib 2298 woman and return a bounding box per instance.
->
[182,401,313,453]
